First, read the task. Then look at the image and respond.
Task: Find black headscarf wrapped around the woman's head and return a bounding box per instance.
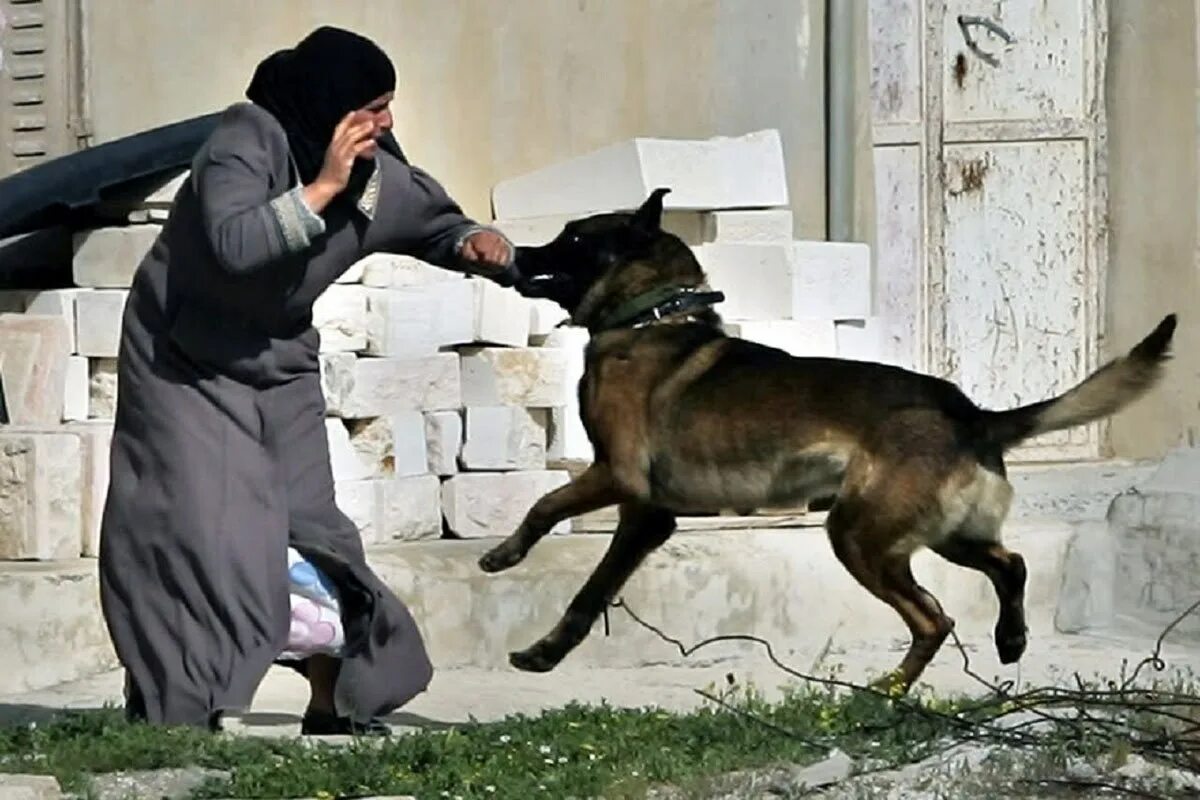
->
[246,25,404,191]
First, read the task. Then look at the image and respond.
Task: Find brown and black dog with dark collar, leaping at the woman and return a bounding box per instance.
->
[479,190,1176,692]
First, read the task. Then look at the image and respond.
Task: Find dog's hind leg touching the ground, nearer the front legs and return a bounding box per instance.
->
[827,500,954,694]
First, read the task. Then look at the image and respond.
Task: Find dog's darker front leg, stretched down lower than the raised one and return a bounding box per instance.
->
[509,503,676,672]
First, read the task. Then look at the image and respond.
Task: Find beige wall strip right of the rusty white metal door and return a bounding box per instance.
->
[1106,0,1200,457]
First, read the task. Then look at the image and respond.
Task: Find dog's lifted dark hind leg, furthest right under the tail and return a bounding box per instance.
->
[932,542,1028,664]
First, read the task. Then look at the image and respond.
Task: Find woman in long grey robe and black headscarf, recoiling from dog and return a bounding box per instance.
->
[100,28,512,734]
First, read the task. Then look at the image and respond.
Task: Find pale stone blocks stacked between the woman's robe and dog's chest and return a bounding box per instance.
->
[313,254,570,542]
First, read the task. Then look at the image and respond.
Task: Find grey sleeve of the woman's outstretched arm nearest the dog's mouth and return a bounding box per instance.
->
[389,164,512,272]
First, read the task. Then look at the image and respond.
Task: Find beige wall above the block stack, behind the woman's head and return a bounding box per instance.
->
[88,0,824,237]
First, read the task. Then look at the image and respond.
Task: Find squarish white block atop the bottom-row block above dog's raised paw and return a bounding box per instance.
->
[458,405,550,471]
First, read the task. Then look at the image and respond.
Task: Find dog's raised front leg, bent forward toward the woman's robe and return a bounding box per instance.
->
[479,464,623,572]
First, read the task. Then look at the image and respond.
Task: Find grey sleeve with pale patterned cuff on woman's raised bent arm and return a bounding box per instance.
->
[192,104,325,275]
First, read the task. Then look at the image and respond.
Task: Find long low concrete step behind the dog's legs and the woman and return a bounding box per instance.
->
[0,521,1089,693]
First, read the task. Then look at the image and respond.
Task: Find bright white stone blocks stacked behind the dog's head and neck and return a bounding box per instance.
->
[484,130,881,468]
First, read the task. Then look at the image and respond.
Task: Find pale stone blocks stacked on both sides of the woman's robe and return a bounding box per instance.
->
[0,175,585,560]
